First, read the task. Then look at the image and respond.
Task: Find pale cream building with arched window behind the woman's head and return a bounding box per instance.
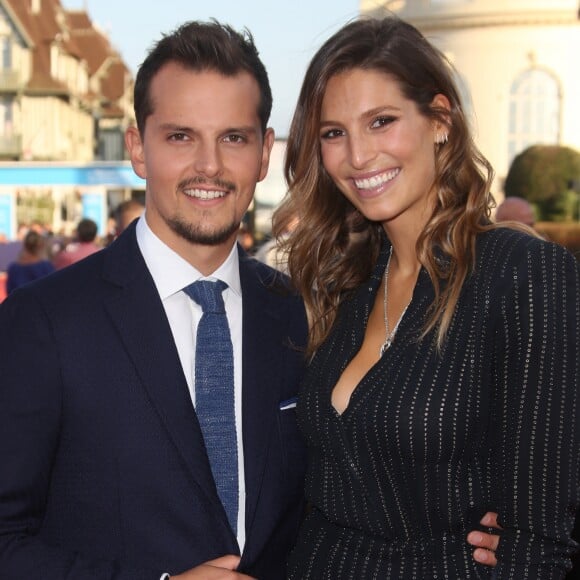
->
[360,0,580,193]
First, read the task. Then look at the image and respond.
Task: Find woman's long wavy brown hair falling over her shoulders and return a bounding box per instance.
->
[273,16,494,354]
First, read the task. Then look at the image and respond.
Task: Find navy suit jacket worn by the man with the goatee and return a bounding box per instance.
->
[0,225,306,580]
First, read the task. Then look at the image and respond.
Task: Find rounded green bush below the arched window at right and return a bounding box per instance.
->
[505,145,580,221]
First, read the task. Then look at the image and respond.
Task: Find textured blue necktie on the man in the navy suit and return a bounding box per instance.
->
[183,280,238,534]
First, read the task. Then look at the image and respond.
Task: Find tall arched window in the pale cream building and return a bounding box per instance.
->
[508,69,561,164]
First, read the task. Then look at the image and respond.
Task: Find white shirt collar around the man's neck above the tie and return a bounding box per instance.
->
[137,214,242,300]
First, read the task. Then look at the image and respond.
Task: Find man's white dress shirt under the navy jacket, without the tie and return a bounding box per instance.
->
[137,214,246,550]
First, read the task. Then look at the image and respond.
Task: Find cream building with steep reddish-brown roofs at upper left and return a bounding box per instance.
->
[0,0,133,161]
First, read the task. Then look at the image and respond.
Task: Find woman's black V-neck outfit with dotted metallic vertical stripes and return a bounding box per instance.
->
[288,229,580,580]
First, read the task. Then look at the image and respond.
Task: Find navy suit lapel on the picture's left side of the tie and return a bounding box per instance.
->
[104,225,231,534]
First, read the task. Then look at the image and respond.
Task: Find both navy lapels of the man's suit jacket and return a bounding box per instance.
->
[99,230,296,537]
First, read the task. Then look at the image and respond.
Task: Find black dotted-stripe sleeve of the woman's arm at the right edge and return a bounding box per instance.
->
[491,241,580,580]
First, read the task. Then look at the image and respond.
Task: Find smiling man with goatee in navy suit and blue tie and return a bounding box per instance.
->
[0,23,498,580]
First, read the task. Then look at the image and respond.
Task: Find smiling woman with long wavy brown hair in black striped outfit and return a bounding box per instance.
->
[275,18,580,580]
